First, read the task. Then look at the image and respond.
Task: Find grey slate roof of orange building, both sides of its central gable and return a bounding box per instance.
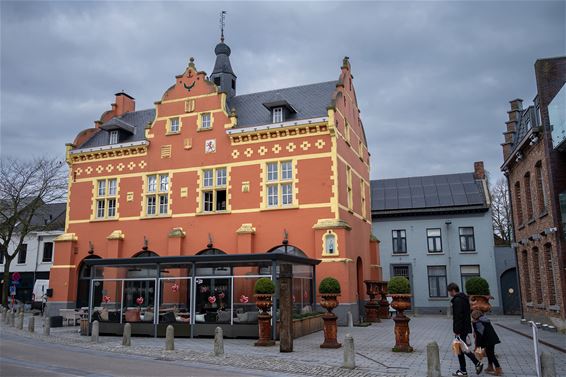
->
[77,81,337,148]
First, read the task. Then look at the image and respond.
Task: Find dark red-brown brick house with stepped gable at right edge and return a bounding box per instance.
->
[501,57,566,329]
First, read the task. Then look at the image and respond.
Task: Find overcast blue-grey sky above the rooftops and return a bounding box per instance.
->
[0,1,566,178]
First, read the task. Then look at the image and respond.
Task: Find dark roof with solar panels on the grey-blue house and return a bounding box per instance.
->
[371,173,488,217]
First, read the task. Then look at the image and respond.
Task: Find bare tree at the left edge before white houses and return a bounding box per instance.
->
[0,158,67,306]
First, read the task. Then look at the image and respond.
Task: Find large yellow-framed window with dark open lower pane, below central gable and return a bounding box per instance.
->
[201,168,228,212]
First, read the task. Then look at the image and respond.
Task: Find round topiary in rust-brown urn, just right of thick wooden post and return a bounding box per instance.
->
[318,277,342,348]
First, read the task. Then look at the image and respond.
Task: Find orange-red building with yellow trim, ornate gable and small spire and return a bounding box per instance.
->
[50,36,380,322]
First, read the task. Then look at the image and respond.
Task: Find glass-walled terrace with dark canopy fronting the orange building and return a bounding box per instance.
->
[85,244,320,338]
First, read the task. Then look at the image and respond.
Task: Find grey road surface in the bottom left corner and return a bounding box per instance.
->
[0,333,288,377]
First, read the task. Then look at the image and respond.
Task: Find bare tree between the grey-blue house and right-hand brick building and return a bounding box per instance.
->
[491,178,513,243]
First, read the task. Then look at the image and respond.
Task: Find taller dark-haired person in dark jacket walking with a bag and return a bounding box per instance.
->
[447,283,483,376]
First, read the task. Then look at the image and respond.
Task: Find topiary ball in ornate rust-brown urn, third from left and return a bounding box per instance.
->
[387,276,413,352]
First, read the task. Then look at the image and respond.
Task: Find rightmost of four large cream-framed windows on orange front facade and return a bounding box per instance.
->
[265,161,293,207]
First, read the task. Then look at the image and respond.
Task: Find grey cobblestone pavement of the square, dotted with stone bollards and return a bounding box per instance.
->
[0,316,566,377]
